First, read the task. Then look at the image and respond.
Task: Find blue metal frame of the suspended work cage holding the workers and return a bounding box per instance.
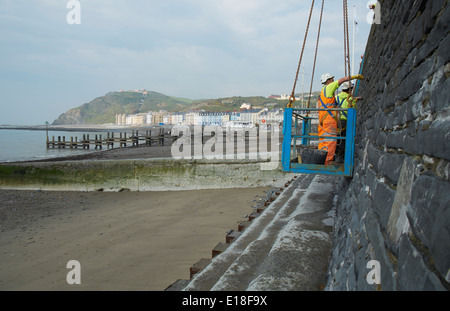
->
[281,108,356,177]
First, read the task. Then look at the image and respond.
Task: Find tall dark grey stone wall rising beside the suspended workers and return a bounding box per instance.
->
[326,0,450,290]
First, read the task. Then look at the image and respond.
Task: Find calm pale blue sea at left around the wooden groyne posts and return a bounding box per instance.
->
[0,129,118,163]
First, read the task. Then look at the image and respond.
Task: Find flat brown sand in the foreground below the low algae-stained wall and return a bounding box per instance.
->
[0,188,270,291]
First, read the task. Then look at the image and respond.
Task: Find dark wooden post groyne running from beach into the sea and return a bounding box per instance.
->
[46,130,178,149]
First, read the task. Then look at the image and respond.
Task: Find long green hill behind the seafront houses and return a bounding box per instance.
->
[53,91,320,125]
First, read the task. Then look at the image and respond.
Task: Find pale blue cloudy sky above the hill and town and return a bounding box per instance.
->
[0,0,373,125]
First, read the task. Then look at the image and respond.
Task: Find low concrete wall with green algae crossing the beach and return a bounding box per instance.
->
[0,159,292,191]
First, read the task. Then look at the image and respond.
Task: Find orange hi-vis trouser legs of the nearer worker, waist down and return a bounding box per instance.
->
[319,111,338,165]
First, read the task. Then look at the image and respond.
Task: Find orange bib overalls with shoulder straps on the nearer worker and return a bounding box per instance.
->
[319,86,338,165]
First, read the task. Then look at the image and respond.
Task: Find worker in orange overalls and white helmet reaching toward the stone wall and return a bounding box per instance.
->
[319,73,364,165]
